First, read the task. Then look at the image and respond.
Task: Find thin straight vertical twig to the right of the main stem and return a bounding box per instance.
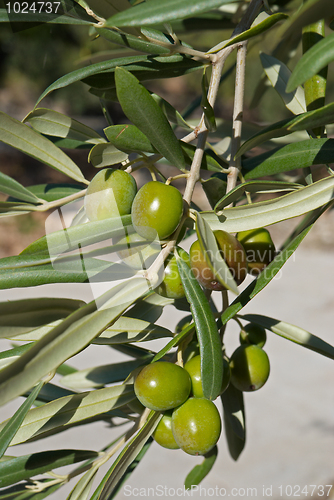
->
[226,41,247,202]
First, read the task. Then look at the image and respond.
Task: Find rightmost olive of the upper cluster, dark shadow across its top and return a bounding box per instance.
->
[237,227,276,275]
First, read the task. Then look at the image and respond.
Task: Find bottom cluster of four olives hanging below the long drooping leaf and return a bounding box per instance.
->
[134,362,221,455]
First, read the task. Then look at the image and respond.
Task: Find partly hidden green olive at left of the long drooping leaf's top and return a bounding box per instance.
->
[155,247,190,299]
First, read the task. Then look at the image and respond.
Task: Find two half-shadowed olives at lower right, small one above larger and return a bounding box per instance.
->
[230,323,270,392]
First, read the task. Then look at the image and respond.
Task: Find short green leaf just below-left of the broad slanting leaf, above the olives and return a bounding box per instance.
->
[104,125,157,153]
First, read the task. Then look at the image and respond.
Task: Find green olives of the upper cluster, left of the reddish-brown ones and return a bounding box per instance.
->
[85,168,189,292]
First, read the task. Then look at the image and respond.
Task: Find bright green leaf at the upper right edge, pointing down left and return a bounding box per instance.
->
[286,33,334,92]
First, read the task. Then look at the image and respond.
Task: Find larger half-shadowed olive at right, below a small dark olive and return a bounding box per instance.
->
[230,344,270,392]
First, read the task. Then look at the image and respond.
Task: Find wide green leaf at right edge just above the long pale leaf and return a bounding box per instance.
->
[243,139,334,179]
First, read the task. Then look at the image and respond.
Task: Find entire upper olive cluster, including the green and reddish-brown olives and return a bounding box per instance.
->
[85,168,275,299]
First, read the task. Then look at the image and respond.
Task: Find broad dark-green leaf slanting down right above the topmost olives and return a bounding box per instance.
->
[115,68,185,168]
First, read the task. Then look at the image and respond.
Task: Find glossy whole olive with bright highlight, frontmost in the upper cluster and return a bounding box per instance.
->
[131,181,183,240]
